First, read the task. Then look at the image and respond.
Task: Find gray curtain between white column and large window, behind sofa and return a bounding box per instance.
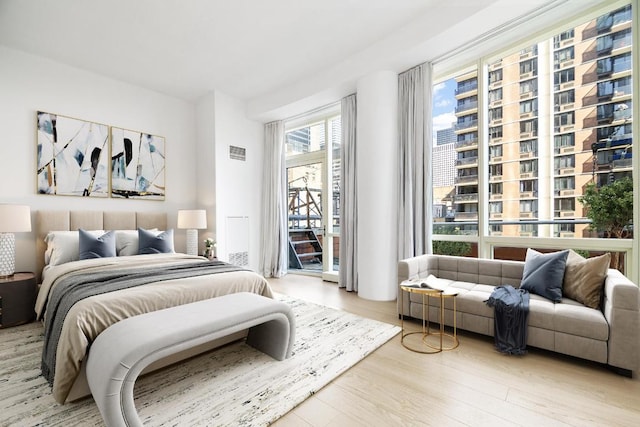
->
[398,63,433,259]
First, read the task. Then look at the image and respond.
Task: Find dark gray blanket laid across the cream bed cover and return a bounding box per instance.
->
[41,261,243,384]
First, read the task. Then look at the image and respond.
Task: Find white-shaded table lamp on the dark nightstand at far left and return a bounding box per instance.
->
[0,204,31,277]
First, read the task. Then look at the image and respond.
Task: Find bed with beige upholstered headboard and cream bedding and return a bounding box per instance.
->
[35,211,273,403]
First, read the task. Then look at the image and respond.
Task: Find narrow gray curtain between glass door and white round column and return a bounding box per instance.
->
[338,94,358,292]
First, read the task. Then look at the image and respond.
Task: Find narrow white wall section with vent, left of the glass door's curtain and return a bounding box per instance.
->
[215,91,264,271]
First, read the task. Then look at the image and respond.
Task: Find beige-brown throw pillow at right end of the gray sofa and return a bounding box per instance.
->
[562,249,611,309]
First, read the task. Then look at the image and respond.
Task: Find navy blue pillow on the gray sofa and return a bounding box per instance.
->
[520,249,569,302]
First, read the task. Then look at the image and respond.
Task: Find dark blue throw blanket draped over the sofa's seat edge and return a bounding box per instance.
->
[485,285,529,355]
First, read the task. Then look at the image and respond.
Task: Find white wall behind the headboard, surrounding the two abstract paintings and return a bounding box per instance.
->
[0,46,197,271]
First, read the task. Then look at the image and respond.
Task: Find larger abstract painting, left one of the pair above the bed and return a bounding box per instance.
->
[37,111,109,197]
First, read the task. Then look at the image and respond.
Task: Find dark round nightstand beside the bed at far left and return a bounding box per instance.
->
[0,273,37,328]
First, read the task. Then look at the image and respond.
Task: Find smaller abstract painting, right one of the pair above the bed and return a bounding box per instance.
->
[111,127,165,200]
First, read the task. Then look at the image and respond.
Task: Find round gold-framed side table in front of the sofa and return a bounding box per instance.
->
[400,283,459,354]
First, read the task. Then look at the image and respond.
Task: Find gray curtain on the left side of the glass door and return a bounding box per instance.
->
[260,121,289,277]
